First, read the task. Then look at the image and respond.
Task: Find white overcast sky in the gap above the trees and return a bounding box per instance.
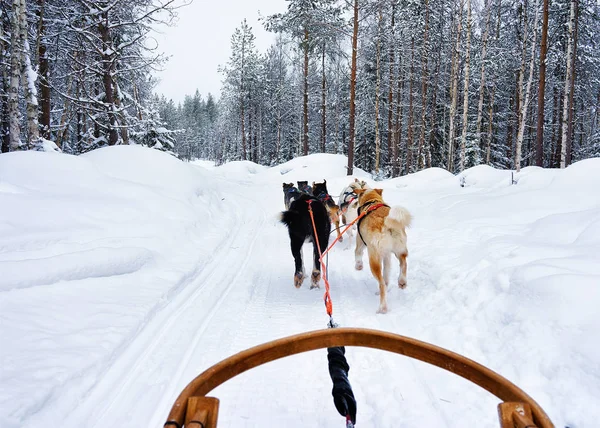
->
[156,0,287,103]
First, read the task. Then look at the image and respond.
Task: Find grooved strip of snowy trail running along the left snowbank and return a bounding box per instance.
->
[64,186,264,427]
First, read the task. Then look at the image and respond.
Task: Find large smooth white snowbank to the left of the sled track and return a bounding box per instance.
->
[0,146,220,427]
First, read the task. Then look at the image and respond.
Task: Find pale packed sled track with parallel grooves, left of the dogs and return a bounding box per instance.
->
[61,195,264,427]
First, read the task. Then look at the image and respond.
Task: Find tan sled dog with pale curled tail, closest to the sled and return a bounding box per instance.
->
[354,189,412,314]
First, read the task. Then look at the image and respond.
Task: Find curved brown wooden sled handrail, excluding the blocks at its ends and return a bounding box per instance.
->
[168,328,554,428]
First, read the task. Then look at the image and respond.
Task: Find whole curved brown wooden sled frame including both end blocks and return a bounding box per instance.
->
[164,328,554,428]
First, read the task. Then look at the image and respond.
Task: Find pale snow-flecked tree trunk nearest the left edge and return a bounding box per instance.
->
[8,0,23,151]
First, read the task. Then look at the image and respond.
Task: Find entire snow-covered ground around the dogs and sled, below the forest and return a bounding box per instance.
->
[0,147,600,428]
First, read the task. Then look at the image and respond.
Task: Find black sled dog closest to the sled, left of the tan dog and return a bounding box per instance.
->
[281,194,331,288]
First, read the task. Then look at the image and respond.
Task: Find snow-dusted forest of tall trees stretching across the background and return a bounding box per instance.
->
[0,0,600,177]
